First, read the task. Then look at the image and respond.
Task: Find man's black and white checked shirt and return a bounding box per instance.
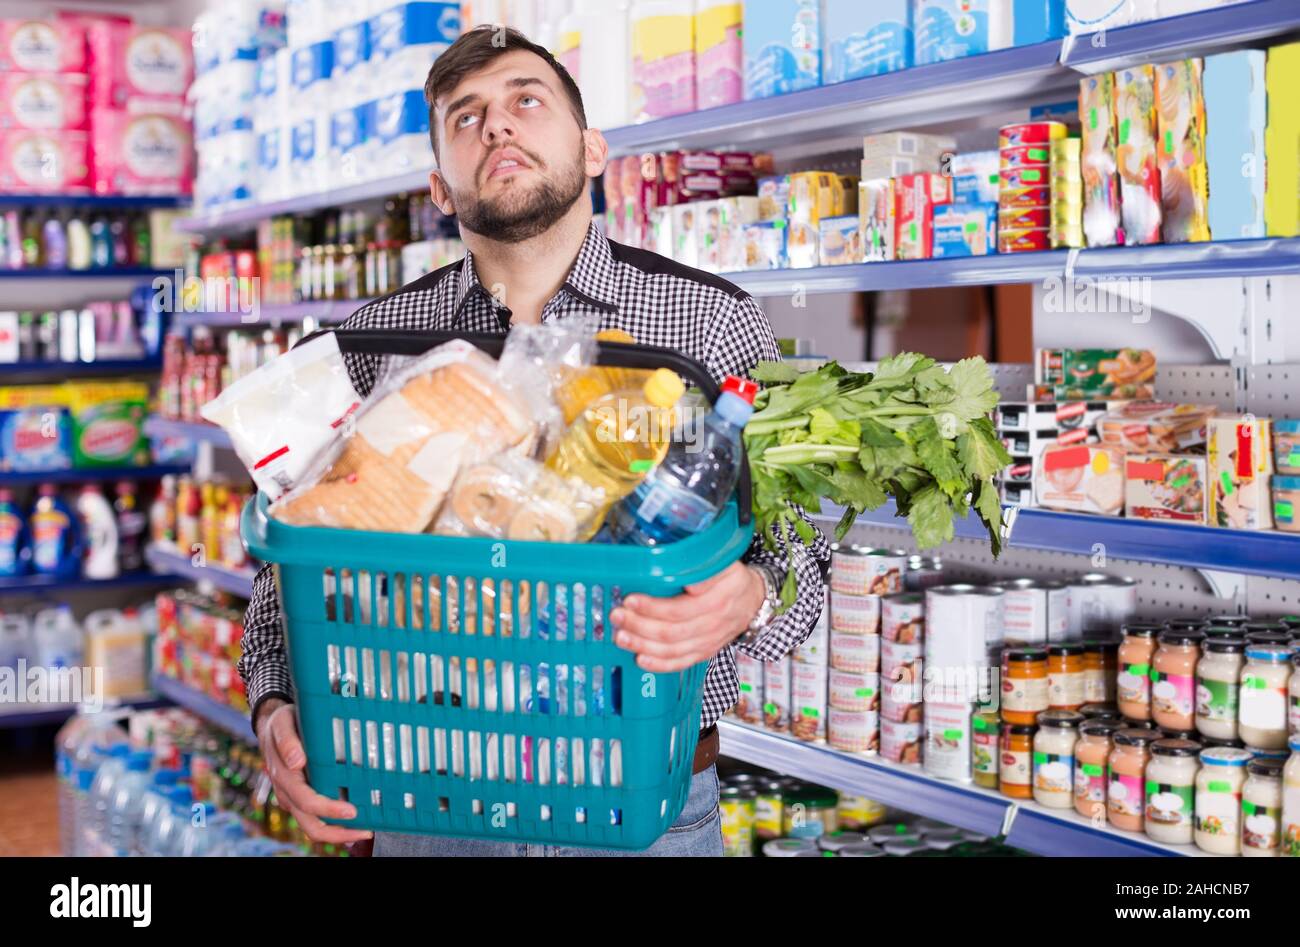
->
[239,226,831,728]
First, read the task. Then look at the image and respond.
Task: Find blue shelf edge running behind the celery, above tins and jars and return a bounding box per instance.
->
[818,501,1300,579]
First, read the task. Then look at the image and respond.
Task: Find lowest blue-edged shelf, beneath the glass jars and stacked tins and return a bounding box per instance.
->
[718,719,1201,856]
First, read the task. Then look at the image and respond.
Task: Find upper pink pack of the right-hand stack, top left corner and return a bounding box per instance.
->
[86,20,194,108]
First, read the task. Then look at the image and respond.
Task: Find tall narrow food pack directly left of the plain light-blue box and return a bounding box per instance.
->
[1156,59,1210,243]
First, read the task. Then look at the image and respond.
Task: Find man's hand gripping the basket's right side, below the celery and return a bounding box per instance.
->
[610,562,767,674]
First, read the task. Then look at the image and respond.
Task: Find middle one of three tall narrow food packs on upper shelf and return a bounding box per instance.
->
[1115,65,1162,246]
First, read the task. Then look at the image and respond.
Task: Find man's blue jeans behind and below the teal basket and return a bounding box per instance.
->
[374,766,723,859]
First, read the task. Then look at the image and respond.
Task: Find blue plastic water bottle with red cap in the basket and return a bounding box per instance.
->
[608,376,758,546]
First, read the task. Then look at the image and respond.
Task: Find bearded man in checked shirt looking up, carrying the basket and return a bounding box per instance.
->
[239,27,829,855]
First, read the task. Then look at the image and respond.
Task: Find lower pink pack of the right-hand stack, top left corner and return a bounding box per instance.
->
[91,108,194,195]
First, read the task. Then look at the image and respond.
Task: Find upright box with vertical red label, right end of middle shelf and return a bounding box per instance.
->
[1205,415,1273,529]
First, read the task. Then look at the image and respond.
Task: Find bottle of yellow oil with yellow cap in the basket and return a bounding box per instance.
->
[546,368,685,540]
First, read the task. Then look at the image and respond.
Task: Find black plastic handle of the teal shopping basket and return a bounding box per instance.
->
[299,329,753,526]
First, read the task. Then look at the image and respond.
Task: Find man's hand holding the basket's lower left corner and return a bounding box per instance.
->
[255,697,374,844]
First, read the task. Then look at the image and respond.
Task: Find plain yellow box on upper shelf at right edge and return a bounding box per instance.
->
[1264,43,1300,237]
